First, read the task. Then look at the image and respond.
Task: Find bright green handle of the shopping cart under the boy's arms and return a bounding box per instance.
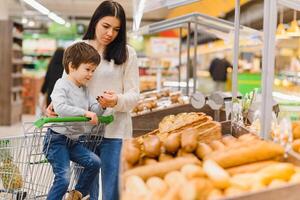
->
[34,115,114,128]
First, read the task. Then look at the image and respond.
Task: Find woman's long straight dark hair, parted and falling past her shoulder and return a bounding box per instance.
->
[83,1,128,65]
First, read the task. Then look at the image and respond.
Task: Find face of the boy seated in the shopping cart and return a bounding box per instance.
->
[69,63,97,86]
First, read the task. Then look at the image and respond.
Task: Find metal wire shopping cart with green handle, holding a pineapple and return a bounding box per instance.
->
[0,115,113,200]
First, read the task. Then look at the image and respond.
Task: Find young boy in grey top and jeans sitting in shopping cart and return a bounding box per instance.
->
[44,42,103,200]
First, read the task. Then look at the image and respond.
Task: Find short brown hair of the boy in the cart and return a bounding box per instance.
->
[63,42,101,74]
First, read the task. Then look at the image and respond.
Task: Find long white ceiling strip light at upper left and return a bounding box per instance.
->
[23,0,66,25]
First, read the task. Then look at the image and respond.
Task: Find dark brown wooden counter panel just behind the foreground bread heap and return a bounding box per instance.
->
[132,104,228,137]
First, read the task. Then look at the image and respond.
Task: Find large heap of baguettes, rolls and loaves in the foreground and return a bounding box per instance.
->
[120,113,300,200]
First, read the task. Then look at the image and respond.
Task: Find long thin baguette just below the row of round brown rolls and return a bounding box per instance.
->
[123,157,201,180]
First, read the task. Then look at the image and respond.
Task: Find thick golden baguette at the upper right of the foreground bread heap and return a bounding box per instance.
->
[204,140,284,168]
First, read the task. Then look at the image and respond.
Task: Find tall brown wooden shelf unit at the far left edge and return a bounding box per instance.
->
[0,20,24,126]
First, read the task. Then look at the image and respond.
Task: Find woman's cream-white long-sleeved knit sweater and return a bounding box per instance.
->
[88,46,140,138]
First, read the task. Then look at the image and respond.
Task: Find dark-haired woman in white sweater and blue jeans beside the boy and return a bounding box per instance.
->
[48,1,139,200]
